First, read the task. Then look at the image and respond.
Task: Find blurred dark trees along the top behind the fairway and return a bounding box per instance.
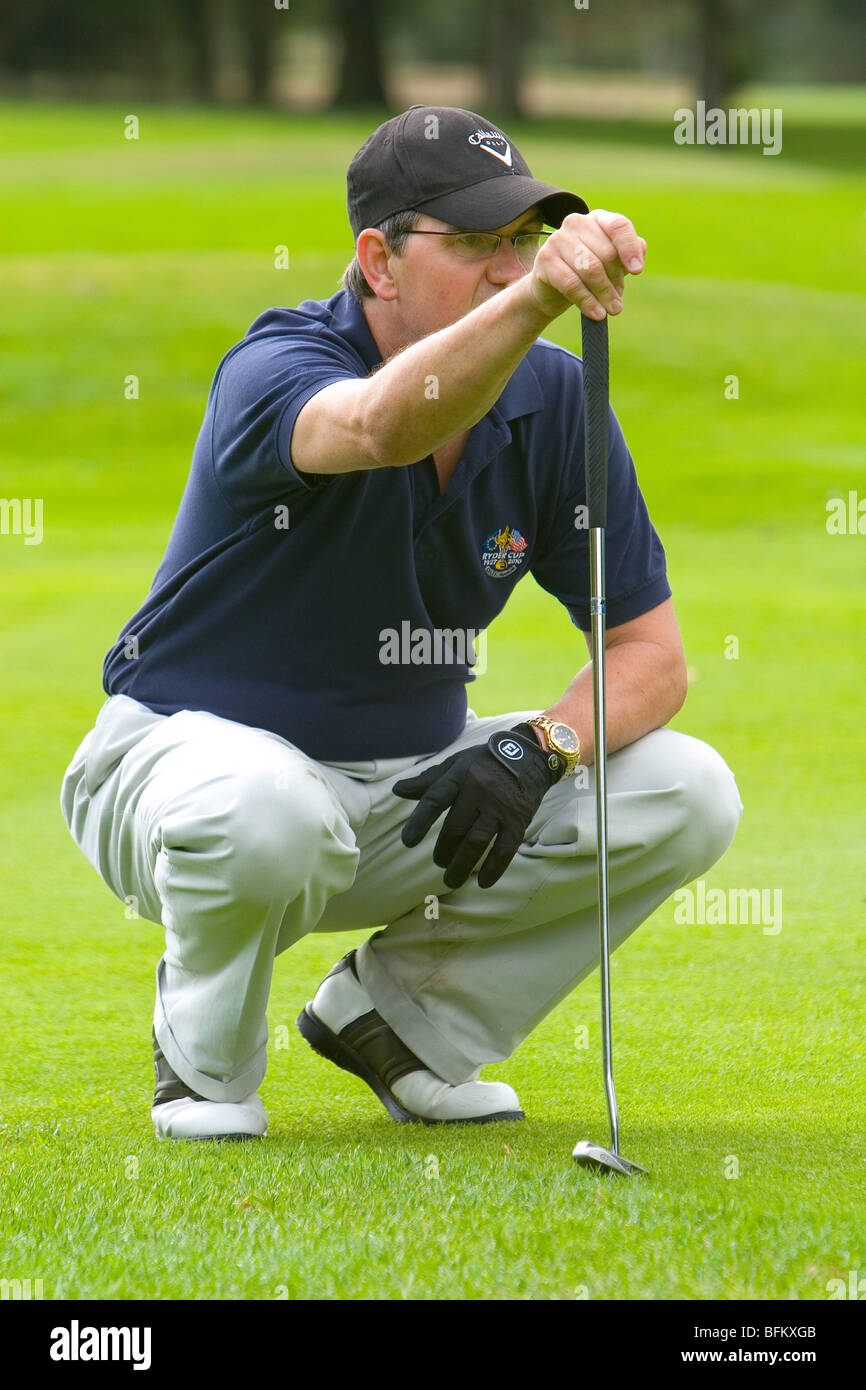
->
[0,0,866,120]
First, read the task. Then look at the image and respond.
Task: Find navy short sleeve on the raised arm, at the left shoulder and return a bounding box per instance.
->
[211,332,364,513]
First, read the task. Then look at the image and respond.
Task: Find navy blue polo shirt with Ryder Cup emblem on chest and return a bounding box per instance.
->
[103,291,670,762]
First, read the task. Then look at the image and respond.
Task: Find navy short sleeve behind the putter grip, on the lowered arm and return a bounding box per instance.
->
[532,397,671,632]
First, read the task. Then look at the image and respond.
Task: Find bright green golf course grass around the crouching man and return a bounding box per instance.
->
[0,100,866,1300]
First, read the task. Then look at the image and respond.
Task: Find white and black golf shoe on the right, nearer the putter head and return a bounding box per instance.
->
[297,951,524,1125]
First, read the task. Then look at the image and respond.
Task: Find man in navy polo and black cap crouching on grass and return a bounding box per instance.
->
[61,106,742,1140]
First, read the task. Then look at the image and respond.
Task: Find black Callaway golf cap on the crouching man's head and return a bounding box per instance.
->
[346,106,589,238]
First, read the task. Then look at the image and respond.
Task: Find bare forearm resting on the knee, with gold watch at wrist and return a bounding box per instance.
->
[530,641,687,763]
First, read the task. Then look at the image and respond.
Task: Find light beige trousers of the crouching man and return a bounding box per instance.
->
[61,695,742,1101]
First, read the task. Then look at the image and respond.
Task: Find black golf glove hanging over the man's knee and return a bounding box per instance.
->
[393,724,566,888]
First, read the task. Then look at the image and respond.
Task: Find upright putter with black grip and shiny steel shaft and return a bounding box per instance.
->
[573,314,646,1176]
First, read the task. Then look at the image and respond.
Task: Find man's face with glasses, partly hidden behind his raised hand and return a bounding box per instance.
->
[389,207,542,342]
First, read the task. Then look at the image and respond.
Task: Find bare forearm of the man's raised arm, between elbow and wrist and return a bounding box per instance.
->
[364,277,552,467]
